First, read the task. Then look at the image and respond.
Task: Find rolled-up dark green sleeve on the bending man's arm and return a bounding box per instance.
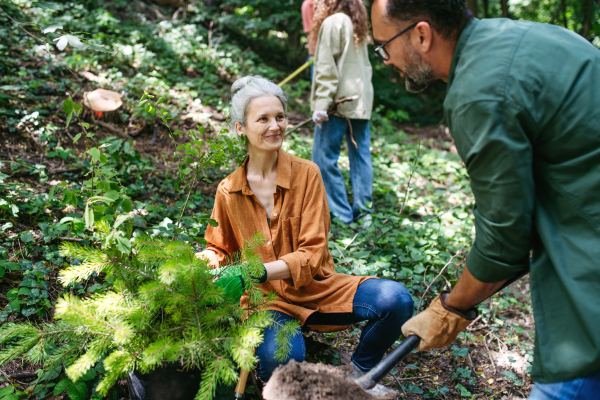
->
[452,101,535,282]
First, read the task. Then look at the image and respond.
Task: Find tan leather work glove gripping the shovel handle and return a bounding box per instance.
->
[402,290,478,351]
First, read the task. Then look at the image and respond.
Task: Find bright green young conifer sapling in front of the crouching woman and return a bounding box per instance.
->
[0,228,274,399]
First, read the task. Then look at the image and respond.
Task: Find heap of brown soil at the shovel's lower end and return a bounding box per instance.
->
[263,360,396,400]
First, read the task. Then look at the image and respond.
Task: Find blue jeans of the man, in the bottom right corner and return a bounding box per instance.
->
[529,371,600,400]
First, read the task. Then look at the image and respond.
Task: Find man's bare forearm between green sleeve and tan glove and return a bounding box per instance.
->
[445,268,506,312]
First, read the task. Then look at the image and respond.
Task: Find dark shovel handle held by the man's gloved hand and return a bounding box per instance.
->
[354,269,529,390]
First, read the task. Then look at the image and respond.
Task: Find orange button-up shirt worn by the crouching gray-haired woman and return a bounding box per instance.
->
[205,150,372,331]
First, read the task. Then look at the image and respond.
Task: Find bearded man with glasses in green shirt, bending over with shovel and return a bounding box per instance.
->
[371,0,600,399]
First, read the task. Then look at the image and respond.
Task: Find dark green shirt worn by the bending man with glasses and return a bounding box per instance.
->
[444,19,600,382]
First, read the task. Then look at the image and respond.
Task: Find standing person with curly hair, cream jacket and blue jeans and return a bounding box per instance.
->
[309,0,373,225]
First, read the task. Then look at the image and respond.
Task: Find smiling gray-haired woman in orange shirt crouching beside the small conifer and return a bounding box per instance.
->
[200,76,413,381]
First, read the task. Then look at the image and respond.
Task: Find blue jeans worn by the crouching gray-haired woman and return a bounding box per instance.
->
[256,279,413,381]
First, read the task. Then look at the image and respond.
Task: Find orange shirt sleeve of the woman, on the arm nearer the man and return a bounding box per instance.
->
[280,166,329,289]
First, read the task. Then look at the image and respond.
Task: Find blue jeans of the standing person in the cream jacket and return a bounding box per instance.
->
[312,115,373,224]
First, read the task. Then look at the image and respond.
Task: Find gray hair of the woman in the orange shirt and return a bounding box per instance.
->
[231,75,287,129]
